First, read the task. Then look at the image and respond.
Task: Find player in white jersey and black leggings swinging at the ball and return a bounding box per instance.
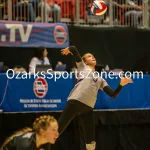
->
[58,46,132,150]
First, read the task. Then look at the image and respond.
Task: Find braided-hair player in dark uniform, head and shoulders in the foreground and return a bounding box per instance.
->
[0,116,58,150]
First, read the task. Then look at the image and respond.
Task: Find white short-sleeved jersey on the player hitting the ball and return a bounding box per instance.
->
[68,61,108,108]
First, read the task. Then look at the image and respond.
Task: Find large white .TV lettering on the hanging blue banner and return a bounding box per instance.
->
[0,24,33,42]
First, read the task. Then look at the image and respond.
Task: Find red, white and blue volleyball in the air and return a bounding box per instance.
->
[91,0,107,16]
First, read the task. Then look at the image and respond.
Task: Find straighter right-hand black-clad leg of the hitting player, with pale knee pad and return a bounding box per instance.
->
[79,110,96,150]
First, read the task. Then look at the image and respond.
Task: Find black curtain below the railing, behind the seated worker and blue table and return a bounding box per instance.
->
[0,26,150,72]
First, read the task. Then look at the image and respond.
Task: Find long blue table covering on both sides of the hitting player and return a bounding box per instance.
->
[0,74,150,112]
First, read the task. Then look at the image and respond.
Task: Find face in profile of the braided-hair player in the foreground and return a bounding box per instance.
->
[43,122,59,144]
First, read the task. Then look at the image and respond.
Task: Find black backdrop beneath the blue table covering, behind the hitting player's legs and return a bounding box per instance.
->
[0,110,150,150]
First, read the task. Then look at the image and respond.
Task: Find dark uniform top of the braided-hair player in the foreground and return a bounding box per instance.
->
[1,132,51,150]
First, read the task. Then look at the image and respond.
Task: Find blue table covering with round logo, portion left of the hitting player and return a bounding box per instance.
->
[0,75,74,112]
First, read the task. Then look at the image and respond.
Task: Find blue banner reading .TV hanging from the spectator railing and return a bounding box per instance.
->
[0,20,69,48]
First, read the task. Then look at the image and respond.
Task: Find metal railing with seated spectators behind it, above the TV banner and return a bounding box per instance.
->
[0,0,150,28]
